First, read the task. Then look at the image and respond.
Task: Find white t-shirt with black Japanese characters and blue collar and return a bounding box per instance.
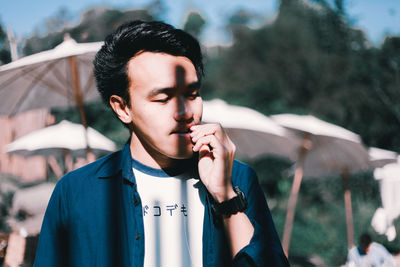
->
[133,160,206,267]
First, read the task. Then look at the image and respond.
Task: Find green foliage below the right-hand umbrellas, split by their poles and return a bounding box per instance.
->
[249,157,388,266]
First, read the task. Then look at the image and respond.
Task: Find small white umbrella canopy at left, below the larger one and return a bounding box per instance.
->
[6,120,116,156]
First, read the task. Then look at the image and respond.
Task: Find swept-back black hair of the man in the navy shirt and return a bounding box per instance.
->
[93,20,203,107]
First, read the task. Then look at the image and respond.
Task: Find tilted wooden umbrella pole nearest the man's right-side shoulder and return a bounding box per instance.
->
[282,135,311,257]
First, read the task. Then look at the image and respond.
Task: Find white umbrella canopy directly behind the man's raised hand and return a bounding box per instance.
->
[202,99,299,159]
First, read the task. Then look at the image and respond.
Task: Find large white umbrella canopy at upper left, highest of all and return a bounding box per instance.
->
[0,38,103,121]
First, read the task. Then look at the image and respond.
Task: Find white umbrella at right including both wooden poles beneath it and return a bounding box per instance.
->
[272,114,369,253]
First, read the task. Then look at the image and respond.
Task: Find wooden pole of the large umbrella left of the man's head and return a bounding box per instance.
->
[68,56,93,161]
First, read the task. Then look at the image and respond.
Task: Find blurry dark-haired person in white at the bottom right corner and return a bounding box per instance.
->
[347,233,394,267]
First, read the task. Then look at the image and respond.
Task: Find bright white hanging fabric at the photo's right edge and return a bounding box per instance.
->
[371,161,400,241]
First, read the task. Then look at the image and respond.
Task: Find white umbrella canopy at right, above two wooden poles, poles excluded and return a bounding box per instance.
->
[272,114,369,178]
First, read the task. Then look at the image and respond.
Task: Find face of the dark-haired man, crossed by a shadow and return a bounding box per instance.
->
[128,52,202,166]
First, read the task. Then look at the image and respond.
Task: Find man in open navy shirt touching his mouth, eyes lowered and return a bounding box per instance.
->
[35,21,288,267]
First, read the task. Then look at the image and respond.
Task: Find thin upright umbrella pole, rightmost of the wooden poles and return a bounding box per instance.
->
[342,168,354,249]
